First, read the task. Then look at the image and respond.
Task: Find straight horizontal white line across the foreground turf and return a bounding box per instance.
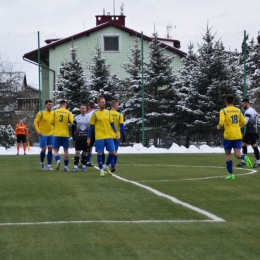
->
[0,220,219,226]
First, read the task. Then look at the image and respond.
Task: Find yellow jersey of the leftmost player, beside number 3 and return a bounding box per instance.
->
[33,110,53,135]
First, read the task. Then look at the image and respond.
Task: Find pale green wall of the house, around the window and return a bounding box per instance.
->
[42,26,182,100]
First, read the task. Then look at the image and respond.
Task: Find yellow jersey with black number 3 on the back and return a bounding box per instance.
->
[51,108,74,137]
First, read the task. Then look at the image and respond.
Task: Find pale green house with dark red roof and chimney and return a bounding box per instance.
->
[23,10,186,103]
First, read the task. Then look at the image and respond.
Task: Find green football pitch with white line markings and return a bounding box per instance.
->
[0,154,260,260]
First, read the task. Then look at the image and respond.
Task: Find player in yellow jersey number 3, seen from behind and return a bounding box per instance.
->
[51,100,74,172]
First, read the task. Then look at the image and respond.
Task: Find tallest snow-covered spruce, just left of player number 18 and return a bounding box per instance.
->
[178,27,243,144]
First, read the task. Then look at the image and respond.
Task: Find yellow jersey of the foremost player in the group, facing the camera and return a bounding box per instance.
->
[89,109,116,140]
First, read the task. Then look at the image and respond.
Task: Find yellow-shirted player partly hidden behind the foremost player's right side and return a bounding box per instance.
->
[110,100,125,172]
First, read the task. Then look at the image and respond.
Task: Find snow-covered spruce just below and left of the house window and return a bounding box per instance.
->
[85,46,120,106]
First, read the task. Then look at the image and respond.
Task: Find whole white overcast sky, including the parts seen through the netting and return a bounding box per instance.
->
[0,0,260,88]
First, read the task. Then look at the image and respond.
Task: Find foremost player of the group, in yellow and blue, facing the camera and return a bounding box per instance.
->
[88,97,119,177]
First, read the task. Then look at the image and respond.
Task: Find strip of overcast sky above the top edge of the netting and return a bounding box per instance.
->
[0,0,260,37]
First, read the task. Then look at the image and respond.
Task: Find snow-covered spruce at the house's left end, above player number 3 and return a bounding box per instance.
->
[54,47,86,111]
